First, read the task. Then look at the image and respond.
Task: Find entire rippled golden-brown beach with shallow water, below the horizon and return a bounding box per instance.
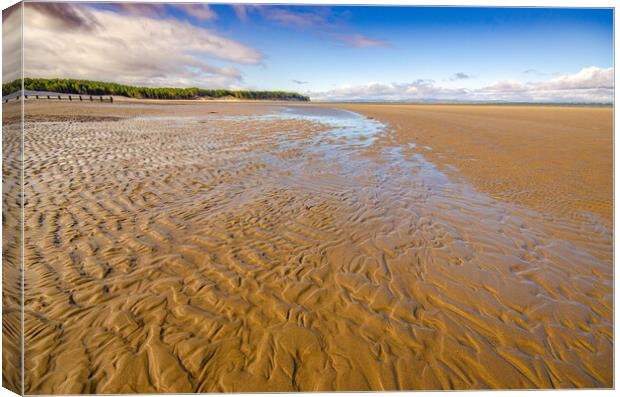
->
[12,101,613,394]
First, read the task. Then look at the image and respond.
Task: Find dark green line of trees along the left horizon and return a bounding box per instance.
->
[2,78,310,101]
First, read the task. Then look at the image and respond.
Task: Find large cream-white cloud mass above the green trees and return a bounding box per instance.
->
[24,3,263,87]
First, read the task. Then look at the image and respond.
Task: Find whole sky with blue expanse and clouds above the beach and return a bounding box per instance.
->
[3,3,613,102]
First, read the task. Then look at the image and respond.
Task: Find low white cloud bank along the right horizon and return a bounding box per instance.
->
[307,66,614,102]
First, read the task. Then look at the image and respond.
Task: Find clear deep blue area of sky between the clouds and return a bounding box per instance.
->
[213,6,613,91]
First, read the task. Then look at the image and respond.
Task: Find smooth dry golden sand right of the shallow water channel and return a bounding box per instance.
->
[334,104,613,225]
